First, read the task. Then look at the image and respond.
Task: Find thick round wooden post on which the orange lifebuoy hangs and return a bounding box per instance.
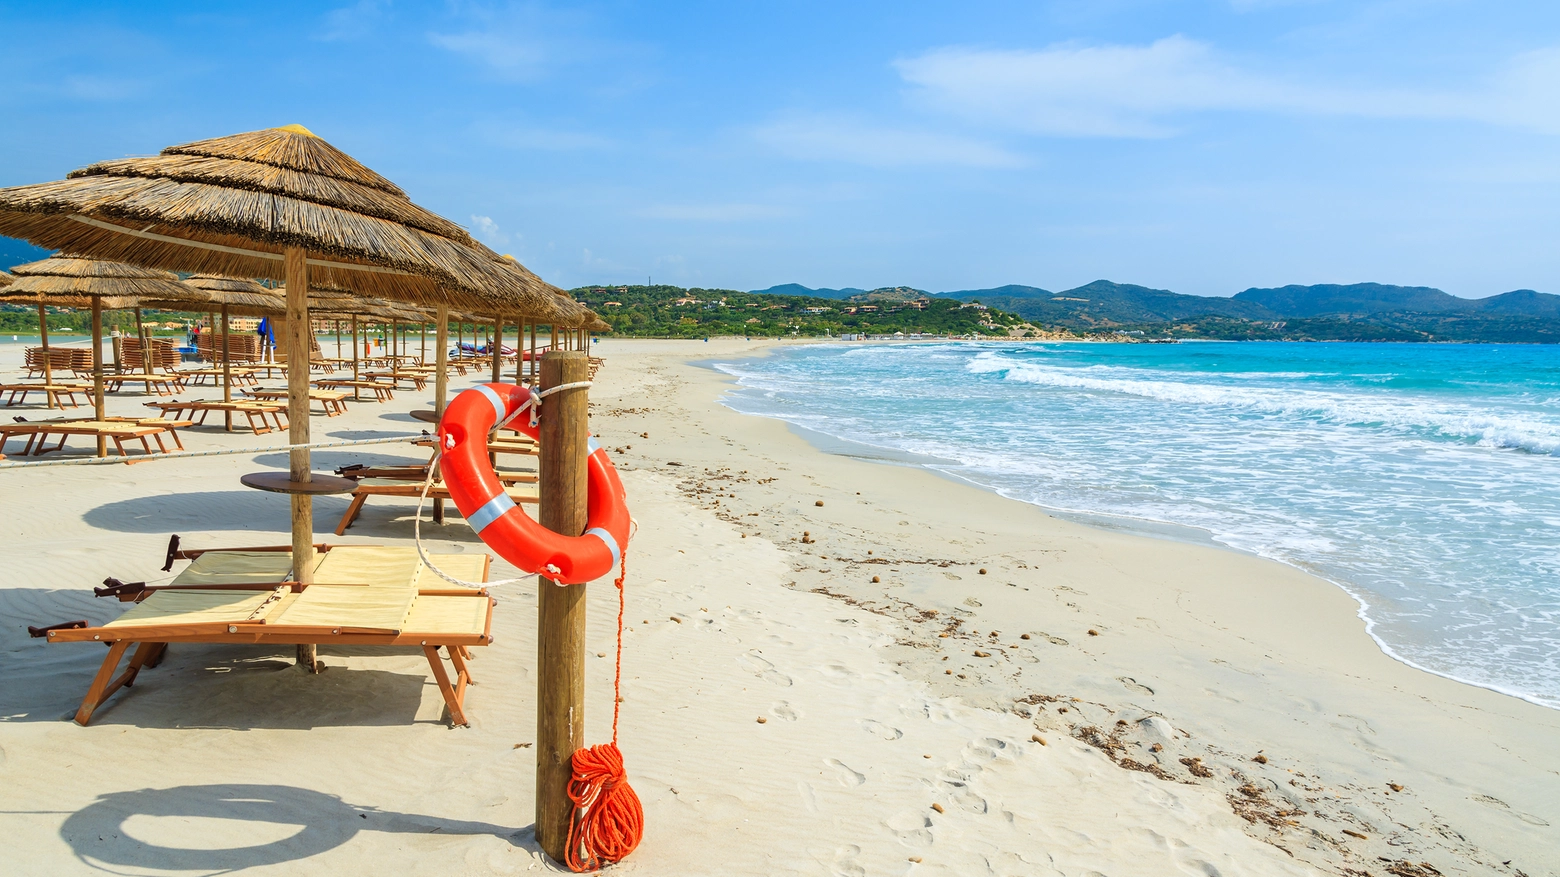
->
[535,351,588,861]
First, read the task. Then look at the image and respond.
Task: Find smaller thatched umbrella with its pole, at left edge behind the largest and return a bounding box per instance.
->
[0,256,199,443]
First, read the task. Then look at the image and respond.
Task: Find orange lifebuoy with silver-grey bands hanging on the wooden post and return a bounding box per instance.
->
[438,384,629,585]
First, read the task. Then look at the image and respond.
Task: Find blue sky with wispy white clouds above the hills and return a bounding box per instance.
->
[0,0,1560,296]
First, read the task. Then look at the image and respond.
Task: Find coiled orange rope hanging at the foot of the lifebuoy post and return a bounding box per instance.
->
[565,552,644,871]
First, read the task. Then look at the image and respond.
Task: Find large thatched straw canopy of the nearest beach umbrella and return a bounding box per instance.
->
[0,125,554,314]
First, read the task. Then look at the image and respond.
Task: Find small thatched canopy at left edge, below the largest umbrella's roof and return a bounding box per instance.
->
[0,256,190,311]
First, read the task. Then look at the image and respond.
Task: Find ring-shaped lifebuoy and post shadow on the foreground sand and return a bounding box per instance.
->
[59,783,540,874]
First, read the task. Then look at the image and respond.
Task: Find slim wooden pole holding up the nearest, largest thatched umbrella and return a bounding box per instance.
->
[285,247,318,673]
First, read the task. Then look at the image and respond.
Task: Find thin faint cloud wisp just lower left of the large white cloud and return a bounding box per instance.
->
[753,115,1023,167]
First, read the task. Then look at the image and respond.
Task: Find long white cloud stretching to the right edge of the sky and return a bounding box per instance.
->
[895,36,1560,137]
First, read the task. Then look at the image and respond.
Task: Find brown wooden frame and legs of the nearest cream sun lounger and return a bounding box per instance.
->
[42,537,498,727]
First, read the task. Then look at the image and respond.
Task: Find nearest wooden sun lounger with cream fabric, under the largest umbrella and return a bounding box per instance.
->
[44,546,498,726]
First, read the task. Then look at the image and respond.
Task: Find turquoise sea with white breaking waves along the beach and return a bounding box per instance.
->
[718,342,1560,708]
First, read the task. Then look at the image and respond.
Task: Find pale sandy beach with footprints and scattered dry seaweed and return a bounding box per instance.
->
[0,339,1560,877]
